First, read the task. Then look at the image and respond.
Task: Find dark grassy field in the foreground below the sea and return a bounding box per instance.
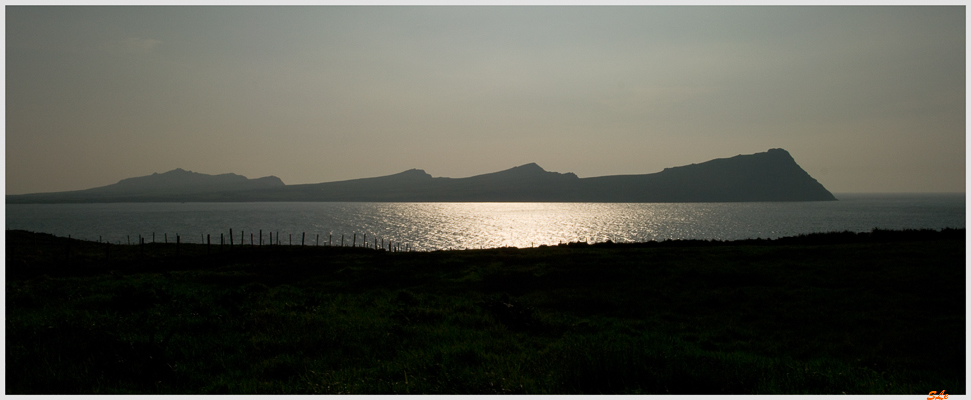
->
[6,230,966,396]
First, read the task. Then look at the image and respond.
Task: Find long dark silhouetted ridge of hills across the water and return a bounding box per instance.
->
[7,149,836,203]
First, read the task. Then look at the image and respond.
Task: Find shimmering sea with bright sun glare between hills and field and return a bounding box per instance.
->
[6,194,965,250]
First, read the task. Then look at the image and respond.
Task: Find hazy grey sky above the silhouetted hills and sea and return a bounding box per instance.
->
[6,6,966,194]
